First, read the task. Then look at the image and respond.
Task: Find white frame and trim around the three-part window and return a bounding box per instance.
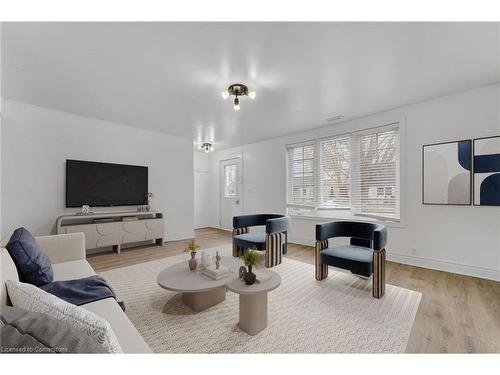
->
[285,118,406,227]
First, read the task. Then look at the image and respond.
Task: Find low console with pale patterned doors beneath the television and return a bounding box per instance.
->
[56,211,164,253]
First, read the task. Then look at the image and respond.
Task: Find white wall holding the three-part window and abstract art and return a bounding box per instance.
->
[210,84,500,280]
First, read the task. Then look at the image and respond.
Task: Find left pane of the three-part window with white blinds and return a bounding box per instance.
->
[287,144,315,207]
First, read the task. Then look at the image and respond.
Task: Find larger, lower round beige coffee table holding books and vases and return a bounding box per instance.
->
[157,256,241,311]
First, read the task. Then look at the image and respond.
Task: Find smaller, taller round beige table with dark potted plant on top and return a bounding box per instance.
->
[226,269,281,336]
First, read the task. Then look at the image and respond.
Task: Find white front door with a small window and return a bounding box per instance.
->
[219,158,243,229]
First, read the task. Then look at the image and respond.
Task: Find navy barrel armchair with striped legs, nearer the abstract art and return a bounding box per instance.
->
[315,221,387,298]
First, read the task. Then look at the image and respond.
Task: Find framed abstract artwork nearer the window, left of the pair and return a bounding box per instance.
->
[422,139,472,205]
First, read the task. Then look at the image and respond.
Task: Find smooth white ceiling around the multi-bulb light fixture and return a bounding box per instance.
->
[2,23,500,149]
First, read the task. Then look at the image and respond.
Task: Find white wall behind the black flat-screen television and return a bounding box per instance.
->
[1,101,193,244]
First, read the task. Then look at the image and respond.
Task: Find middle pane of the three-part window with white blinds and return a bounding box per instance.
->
[319,137,351,209]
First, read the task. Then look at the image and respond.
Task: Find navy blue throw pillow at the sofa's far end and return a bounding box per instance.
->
[5,228,54,286]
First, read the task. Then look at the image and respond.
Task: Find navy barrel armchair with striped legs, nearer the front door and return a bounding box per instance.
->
[233,214,290,268]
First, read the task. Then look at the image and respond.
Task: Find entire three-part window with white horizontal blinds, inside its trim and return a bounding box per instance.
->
[287,123,400,221]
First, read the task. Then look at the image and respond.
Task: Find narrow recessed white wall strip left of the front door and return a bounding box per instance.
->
[194,150,210,228]
